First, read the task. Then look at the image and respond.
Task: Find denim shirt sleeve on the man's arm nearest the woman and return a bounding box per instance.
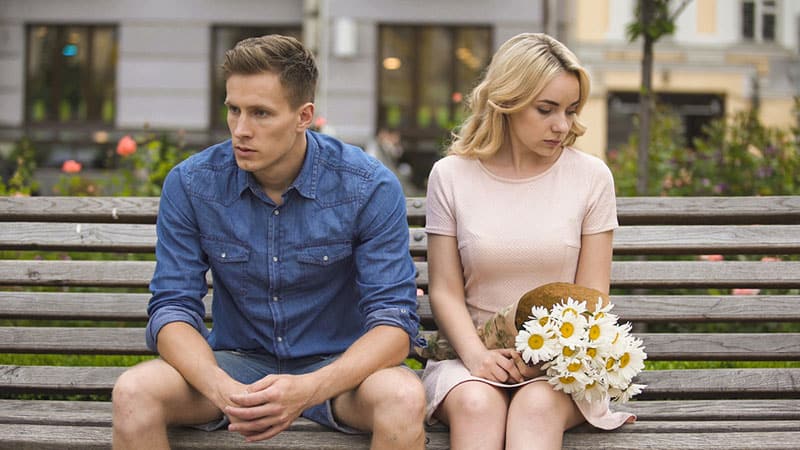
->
[354,167,423,344]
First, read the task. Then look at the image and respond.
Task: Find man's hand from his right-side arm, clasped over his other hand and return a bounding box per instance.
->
[224,375,322,442]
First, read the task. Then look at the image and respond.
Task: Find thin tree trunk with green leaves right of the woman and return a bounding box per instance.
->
[627,0,691,195]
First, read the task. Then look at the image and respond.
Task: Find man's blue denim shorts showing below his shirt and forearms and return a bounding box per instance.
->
[193,350,366,434]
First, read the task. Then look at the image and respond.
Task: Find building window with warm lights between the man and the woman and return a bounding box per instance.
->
[377,25,492,184]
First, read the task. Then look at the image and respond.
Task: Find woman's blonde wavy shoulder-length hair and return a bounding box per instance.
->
[447,33,589,159]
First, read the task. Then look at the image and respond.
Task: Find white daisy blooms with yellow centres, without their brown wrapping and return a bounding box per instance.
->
[515,297,647,403]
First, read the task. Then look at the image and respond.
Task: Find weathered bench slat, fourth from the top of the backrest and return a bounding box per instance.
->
[0,291,800,325]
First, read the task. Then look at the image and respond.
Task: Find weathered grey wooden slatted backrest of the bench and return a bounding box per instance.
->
[0,196,800,400]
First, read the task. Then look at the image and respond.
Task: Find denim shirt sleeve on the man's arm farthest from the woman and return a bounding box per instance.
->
[146,165,209,351]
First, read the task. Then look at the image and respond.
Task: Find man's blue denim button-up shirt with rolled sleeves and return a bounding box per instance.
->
[147,131,419,359]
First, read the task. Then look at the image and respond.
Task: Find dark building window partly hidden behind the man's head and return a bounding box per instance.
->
[211,25,303,130]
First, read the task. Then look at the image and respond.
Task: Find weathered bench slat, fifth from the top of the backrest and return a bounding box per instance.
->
[0,327,800,361]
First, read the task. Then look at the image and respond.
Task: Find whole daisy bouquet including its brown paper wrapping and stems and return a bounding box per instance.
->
[415,283,647,403]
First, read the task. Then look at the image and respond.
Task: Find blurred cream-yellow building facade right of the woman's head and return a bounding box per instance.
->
[566,0,800,154]
